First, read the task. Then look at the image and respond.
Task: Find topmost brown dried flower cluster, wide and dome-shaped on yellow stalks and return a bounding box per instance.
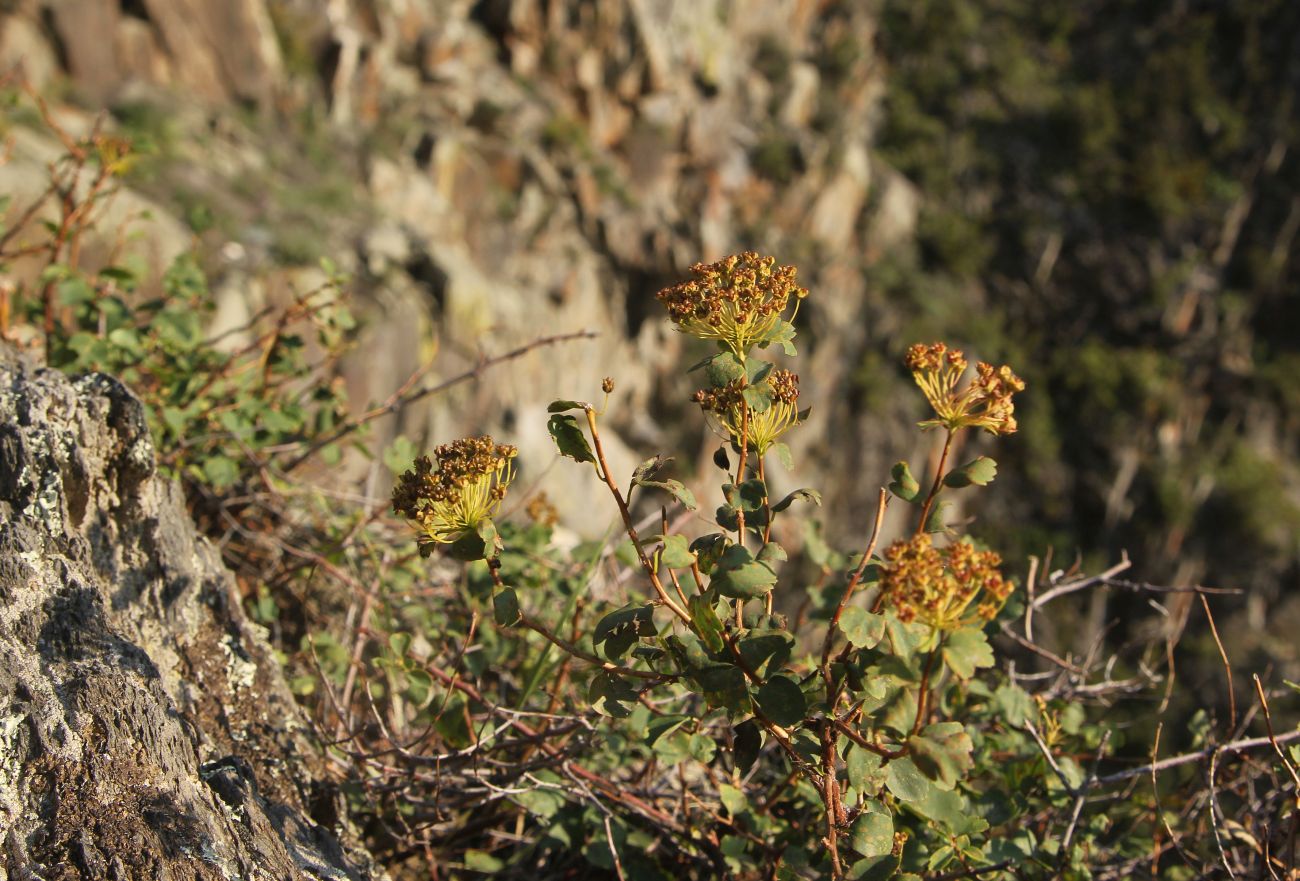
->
[658,251,807,359]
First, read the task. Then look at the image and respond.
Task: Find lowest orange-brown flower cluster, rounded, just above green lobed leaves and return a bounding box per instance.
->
[880,533,1011,630]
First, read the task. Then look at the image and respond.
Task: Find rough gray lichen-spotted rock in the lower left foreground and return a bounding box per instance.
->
[0,348,374,880]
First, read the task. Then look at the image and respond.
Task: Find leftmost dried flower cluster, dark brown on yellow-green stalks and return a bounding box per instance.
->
[393,437,519,548]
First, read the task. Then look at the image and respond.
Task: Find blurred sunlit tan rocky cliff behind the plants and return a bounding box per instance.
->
[0,0,918,543]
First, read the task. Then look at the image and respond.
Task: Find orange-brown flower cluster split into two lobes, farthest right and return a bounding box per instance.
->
[905,343,1024,434]
